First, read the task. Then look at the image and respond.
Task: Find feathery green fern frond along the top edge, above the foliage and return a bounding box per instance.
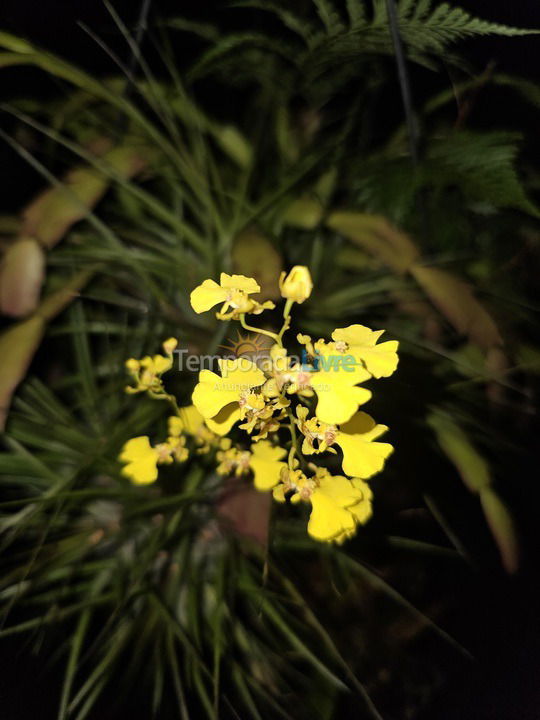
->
[194,0,539,96]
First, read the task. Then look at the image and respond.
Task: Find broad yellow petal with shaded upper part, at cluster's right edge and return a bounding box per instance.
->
[336,412,394,478]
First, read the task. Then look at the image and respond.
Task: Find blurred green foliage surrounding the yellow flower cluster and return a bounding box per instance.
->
[0,0,540,720]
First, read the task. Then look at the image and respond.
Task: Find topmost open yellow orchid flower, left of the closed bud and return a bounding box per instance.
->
[190,273,275,320]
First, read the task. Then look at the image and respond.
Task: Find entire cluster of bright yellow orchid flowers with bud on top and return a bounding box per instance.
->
[120,266,398,542]
